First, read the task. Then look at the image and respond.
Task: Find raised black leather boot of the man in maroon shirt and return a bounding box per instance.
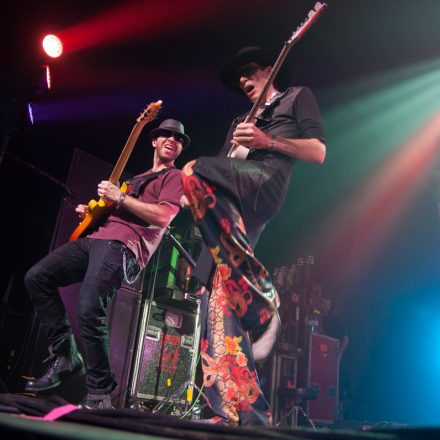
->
[25,336,86,392]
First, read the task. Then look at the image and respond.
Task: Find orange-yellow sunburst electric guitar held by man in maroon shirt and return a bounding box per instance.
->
[69,101,162,241]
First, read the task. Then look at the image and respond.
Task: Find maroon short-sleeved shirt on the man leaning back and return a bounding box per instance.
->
[88,168,183,269]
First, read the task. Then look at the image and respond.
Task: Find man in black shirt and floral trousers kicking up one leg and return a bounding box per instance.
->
[183,47,326,424]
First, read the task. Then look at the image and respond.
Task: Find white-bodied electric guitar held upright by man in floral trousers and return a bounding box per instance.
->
[228,2,327,160]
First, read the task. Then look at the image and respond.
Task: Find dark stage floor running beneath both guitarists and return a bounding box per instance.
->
[0,394,440,440]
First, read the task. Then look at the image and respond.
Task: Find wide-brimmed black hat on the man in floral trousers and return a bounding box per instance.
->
[220,46,292,95]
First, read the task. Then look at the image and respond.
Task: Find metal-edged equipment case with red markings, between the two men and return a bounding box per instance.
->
[130,301,200,406]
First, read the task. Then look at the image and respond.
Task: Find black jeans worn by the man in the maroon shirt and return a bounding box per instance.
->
[25,238,139,394]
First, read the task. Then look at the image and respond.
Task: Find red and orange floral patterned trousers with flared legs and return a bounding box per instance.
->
[183,161,279,425]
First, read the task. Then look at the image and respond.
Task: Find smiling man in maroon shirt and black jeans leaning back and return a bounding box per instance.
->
[25,119,190,409]
